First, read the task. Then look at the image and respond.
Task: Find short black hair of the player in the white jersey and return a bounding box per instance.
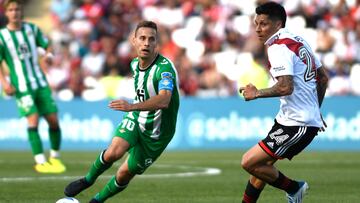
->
[255,1,286,27]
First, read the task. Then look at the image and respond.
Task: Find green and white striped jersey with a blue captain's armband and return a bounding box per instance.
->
[127,54,180,139]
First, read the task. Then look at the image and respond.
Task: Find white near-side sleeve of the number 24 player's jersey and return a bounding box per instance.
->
[268,44,294,77]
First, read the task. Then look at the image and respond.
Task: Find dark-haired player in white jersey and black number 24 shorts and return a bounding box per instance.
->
[240,2,328,203]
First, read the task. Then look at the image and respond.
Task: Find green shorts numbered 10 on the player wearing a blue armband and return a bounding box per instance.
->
[114,116,173,174]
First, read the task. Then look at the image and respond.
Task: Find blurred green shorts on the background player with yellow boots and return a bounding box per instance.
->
[15,87,58,116]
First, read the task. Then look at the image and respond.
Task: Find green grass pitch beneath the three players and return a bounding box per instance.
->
[0,151,360,203]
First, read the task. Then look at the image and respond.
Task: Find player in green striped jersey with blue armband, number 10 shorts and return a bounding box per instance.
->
[64,21,179,203]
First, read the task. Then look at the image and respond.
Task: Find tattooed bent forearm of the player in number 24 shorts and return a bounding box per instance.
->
[255,75,294,98]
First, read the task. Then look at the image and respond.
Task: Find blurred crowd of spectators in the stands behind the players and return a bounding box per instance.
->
[0,0,360,101]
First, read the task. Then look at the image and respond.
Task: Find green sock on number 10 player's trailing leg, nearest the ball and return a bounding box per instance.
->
[95,176,128,202]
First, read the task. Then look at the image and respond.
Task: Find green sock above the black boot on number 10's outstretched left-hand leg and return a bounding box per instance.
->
[85,150,112,184]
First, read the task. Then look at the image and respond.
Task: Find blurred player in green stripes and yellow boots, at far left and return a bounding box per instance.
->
[0,0,66,173]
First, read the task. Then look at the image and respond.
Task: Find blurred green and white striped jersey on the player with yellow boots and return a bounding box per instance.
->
[0,22,49,93]
